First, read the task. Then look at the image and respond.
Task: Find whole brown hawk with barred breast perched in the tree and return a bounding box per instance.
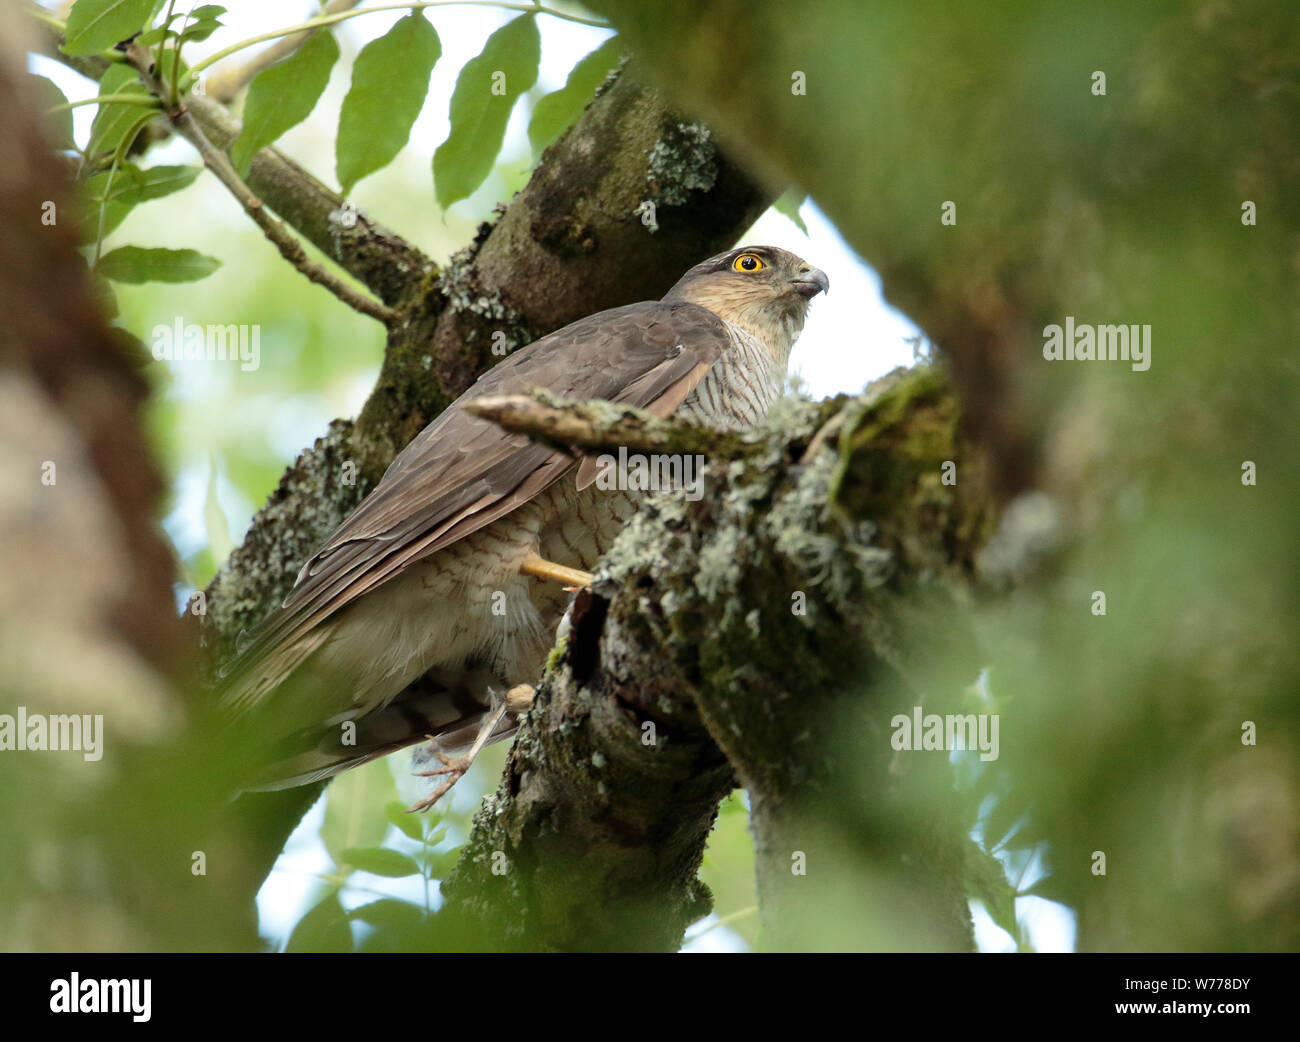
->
[211,246,829,808]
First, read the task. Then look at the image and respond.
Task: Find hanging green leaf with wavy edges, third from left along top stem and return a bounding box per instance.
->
[433,14,542,209]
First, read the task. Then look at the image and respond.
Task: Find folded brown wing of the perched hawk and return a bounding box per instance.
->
[222,301,731,705]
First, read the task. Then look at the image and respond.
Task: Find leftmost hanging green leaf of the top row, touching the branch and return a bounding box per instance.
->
[230,30,338,177]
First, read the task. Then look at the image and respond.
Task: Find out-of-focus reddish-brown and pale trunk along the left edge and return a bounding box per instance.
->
[0,6,257,951]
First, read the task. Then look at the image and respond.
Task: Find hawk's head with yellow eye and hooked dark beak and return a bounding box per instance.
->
[664,246,831,364]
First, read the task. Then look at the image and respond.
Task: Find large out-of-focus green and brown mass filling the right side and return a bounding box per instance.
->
[593,0,1300,950]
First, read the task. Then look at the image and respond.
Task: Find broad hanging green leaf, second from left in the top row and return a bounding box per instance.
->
[334,10,442,195]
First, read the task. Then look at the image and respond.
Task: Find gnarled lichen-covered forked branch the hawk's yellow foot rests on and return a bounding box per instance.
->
[437,370,989,951]
